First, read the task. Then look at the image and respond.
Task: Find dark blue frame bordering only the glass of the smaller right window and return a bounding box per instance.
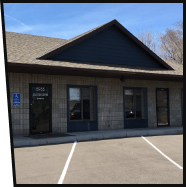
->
[123,87,148,121]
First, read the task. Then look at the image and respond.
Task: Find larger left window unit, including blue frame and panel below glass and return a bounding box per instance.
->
[67,85,98,132]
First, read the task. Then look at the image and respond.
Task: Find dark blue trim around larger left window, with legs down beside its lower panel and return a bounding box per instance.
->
[66,84,98,132]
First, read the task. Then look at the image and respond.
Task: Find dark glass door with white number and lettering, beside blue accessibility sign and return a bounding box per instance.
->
[29,84,51,134]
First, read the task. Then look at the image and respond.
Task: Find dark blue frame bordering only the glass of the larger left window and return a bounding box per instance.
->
[67,84,98,123]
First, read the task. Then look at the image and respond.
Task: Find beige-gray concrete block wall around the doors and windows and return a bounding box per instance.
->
[9,73,183,135]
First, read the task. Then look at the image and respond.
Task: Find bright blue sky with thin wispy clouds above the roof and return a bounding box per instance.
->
[3,3,183,39]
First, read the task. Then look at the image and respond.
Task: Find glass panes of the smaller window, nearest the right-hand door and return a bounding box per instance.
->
[124,89,146,119]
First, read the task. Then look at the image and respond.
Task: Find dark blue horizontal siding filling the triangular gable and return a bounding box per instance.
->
[51,26,162,68]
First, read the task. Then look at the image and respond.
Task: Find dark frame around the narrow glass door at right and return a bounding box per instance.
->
[156,88,170,127]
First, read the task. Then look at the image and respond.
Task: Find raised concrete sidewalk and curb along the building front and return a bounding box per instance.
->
[13,127,183,147]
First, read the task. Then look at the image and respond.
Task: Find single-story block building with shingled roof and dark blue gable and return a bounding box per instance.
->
[5,20,183,135]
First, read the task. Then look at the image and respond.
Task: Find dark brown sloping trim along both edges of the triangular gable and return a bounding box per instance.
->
[37,19,173,70]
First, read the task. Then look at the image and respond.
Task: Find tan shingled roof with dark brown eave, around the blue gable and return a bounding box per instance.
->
[5,21,183,81]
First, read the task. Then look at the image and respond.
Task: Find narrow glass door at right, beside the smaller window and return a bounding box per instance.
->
[156,88,169,126]
